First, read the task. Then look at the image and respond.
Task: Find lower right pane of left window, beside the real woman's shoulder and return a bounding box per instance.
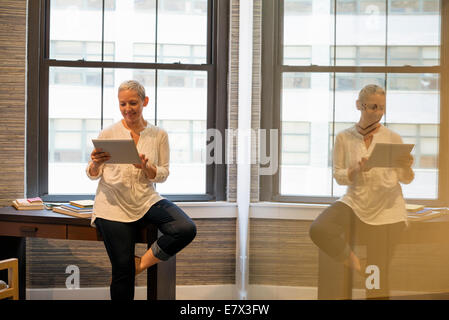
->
[157,70,207,194]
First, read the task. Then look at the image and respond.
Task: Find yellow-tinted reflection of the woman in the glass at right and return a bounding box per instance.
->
[310,85,414,296]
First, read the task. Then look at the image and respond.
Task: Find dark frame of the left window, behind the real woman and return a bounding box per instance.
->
[25,0,230,202]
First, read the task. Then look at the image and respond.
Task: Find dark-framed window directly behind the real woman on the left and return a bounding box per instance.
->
[27,0,229,201]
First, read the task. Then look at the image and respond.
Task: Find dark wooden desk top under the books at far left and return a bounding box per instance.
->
[0,207,90,226]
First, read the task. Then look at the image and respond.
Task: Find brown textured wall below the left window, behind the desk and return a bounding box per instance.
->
[26,219,236,288]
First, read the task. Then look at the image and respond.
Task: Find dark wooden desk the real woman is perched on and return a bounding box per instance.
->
[0,207,176,300]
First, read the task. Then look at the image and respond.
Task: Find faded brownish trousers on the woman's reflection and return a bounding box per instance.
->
[309,201,406,298]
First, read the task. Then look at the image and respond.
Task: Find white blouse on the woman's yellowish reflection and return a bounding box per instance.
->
[334,125,414,225]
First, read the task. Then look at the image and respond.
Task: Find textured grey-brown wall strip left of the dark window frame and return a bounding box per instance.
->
[0,0,27,206]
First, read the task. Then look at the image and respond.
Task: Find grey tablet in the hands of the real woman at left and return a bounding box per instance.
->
[92,139,140,164]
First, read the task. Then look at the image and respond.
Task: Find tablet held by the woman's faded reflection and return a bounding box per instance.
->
[365,143,415,168]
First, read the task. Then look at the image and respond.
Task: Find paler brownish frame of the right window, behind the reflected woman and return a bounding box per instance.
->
[260,0,449,206]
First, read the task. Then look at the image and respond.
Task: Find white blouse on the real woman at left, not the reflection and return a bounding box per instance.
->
[86,121,170,226]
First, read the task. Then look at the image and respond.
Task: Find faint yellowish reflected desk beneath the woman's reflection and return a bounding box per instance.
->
[318,215,449,300]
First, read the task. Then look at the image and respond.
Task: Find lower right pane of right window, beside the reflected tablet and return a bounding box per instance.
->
[386,74,440,199]
